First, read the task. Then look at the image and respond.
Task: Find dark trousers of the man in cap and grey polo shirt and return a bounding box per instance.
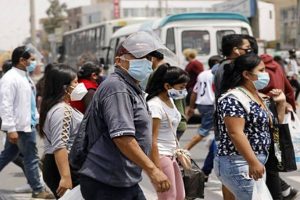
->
[80,175,146,200]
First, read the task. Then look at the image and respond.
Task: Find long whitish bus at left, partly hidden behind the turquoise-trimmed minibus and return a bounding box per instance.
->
[60,17,155,67]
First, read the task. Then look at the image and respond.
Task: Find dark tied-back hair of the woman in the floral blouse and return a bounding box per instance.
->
[220,53,261,94]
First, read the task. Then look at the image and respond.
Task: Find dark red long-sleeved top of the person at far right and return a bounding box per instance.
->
[260,54,296,110]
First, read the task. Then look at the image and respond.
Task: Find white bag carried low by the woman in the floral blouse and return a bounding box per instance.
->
[252,178,273,200]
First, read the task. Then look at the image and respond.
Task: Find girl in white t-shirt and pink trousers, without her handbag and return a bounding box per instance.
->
[146,66,189,200]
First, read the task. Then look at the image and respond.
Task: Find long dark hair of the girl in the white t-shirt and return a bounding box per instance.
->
[146,64,190,101]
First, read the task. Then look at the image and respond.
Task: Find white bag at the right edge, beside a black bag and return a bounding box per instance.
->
[284,112,300,169]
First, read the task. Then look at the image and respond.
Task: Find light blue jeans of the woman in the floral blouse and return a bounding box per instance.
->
[214,154,267,200]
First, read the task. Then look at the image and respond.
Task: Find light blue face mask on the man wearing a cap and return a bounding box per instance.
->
[128,58,153,82]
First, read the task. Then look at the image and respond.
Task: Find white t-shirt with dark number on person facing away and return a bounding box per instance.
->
[193,70,215,105]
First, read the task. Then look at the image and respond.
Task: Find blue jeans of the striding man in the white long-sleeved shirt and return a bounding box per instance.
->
[0,130,43,192]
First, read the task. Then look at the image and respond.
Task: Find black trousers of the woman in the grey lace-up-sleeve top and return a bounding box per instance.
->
[43,154,79,199]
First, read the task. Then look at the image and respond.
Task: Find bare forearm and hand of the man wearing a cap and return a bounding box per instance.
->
[113,136,170,192]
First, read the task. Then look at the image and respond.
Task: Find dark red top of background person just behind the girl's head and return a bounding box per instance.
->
[185,59,204,91]
